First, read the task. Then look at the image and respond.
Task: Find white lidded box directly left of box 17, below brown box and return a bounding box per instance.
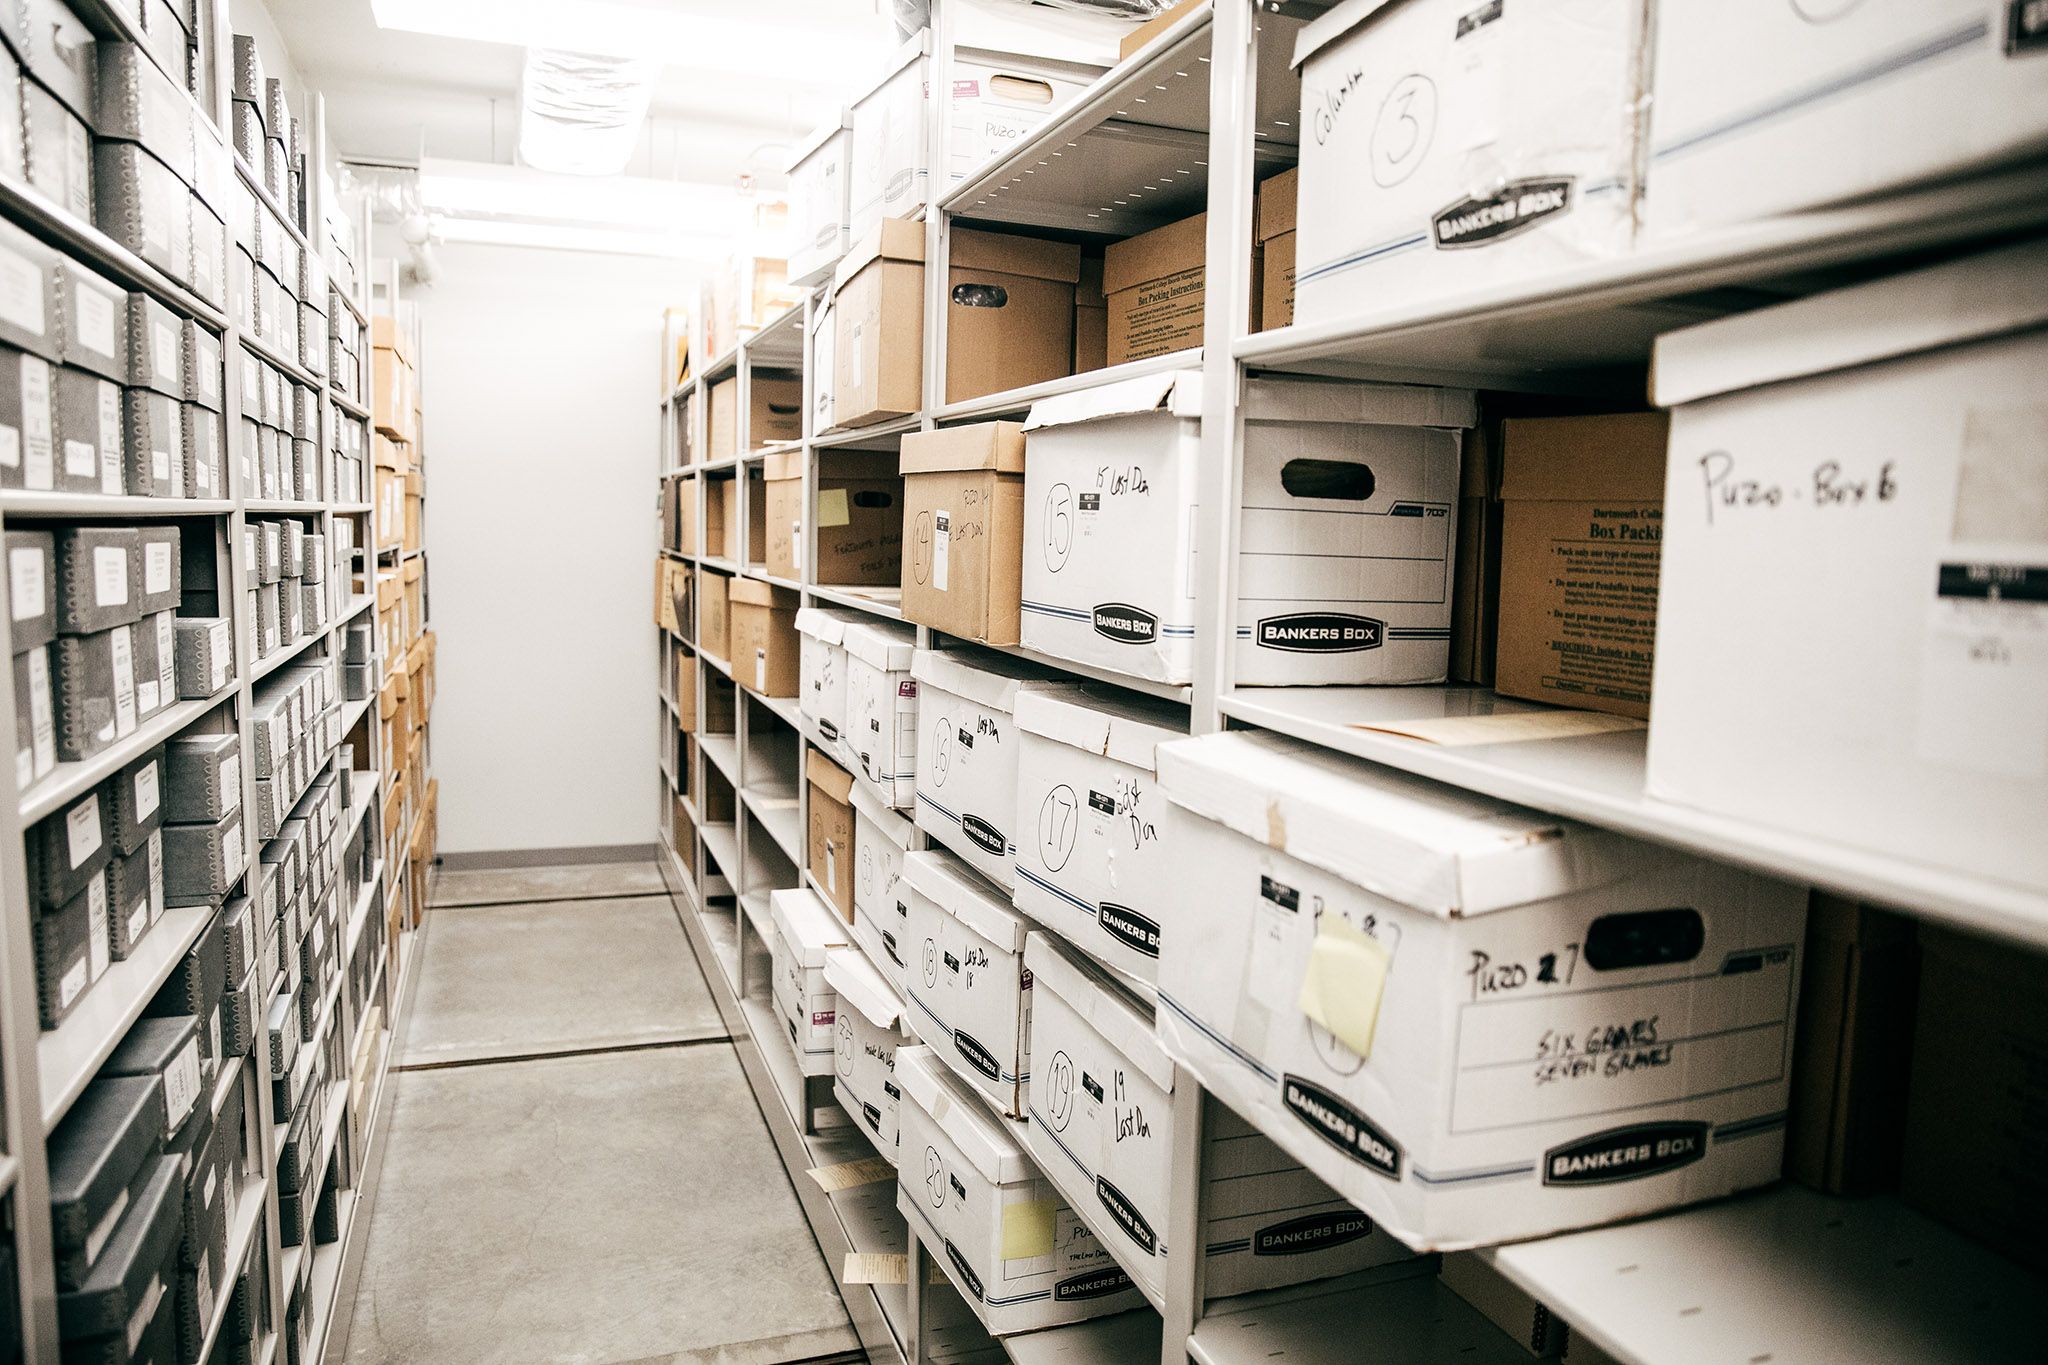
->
[909,649,1073,892]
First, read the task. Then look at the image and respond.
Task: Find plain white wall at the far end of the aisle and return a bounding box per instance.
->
[414,244,694,853]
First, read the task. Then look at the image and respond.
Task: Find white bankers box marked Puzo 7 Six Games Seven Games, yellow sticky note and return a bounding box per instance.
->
[1157,733,1806,1250]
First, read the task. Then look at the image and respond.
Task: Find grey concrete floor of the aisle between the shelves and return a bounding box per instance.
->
[346,870,856,1365]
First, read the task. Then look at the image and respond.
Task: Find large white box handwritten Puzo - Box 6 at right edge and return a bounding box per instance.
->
[1647,241,2048,888]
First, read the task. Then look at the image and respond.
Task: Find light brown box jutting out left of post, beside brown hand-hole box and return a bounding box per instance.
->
[831,219,924,426]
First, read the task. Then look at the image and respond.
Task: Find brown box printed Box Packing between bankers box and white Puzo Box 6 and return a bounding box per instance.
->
[1493,413,1667,716]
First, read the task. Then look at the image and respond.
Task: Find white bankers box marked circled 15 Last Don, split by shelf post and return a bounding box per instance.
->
[1022,370,1475,686]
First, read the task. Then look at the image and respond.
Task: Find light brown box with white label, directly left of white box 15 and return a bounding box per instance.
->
[901,422,1024,645]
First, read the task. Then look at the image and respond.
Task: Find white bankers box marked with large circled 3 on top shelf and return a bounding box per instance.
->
[1294,0,1649,321]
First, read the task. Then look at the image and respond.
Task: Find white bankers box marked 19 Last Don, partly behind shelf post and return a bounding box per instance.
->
[1024,931,1415,1304]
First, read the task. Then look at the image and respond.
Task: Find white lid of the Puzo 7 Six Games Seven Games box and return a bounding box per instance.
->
[1159,733,1638,919]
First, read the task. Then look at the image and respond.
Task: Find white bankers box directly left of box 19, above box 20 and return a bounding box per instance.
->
[903,849,1030,1117]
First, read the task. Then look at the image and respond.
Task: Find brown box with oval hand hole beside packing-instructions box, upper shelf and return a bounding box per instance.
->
[946,227,1081,403]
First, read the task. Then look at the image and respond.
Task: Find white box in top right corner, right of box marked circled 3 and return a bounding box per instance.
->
[1642,0,2048,239]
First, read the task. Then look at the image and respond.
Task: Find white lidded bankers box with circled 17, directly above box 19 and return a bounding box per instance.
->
[1014,688,1188,980]
